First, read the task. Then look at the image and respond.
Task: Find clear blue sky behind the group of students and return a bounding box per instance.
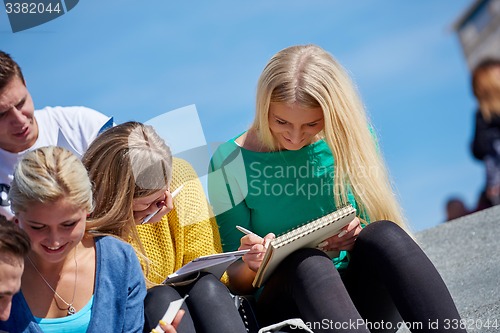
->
[0,0,483,231]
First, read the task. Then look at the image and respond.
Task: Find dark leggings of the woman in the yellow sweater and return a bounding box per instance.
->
[144,274,246,333]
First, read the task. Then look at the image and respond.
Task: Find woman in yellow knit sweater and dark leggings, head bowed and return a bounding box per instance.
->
[83,122,246,333]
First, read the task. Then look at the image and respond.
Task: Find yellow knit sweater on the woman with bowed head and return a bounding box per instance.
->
[137,158,226,284]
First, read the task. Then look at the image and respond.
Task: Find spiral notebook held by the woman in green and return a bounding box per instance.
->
[252,205,356,288]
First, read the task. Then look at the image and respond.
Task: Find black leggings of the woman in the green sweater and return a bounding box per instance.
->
[257,221,466,333]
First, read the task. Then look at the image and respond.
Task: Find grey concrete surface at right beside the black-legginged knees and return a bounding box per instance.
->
[398,206,500,333]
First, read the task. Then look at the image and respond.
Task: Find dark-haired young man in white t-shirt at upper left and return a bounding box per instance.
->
[0,51,113,219]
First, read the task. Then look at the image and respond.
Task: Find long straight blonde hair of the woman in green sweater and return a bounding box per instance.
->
[250,45,408,230]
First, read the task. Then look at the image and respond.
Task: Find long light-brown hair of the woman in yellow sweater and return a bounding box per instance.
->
[82,122,172,281]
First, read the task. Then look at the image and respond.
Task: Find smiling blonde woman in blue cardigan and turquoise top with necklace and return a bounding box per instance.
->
[0,147,146,333]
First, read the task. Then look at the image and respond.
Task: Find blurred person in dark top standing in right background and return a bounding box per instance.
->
[471,59,500,209]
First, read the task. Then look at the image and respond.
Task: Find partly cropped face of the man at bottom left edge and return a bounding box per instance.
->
[0,253,24,320]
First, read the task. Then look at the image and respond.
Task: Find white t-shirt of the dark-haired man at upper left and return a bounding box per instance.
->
[0,106,113,219]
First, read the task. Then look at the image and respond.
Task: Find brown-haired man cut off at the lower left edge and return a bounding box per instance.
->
[0,216,30,320]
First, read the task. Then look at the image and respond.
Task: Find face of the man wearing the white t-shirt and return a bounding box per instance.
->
[0,76,38,153]
